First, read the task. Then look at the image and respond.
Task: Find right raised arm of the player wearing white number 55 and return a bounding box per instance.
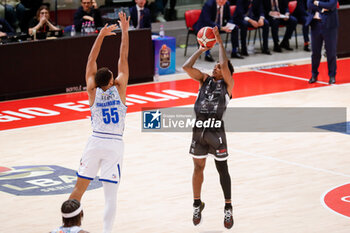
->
[115,12,130,99]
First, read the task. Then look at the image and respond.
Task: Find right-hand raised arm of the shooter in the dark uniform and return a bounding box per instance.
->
[213,27,234,96]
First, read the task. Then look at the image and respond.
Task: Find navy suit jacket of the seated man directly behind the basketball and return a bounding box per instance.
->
[193,0,231,32]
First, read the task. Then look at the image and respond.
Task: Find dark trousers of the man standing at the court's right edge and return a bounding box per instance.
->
[311,20,338,77]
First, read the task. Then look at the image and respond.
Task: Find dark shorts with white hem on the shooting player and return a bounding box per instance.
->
[190,126,228,161]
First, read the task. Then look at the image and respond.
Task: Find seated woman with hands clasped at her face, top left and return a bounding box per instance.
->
[28,5,59,35]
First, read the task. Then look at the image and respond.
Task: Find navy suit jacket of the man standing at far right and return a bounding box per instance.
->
[306,0,339,29]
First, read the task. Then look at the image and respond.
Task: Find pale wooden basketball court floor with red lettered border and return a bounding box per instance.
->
[0,59,350,233]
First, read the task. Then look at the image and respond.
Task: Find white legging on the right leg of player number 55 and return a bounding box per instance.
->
[102,182,119,233]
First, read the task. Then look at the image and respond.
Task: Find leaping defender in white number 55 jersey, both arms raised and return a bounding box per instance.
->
[69,12,130,233]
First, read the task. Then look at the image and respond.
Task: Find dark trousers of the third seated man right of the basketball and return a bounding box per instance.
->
[269,16,297,46]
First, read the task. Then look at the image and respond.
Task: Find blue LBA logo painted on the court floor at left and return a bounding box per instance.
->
[0,165,102,196]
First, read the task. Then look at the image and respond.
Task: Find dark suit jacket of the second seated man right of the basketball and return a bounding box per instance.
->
[233,0,265,22]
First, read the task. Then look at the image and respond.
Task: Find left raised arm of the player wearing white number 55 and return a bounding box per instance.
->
[85,24,117,93]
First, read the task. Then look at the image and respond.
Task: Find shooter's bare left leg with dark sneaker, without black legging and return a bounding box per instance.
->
[192,158,206,226]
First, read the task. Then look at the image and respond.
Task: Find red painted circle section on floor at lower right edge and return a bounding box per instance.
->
[322,183,350,218]
